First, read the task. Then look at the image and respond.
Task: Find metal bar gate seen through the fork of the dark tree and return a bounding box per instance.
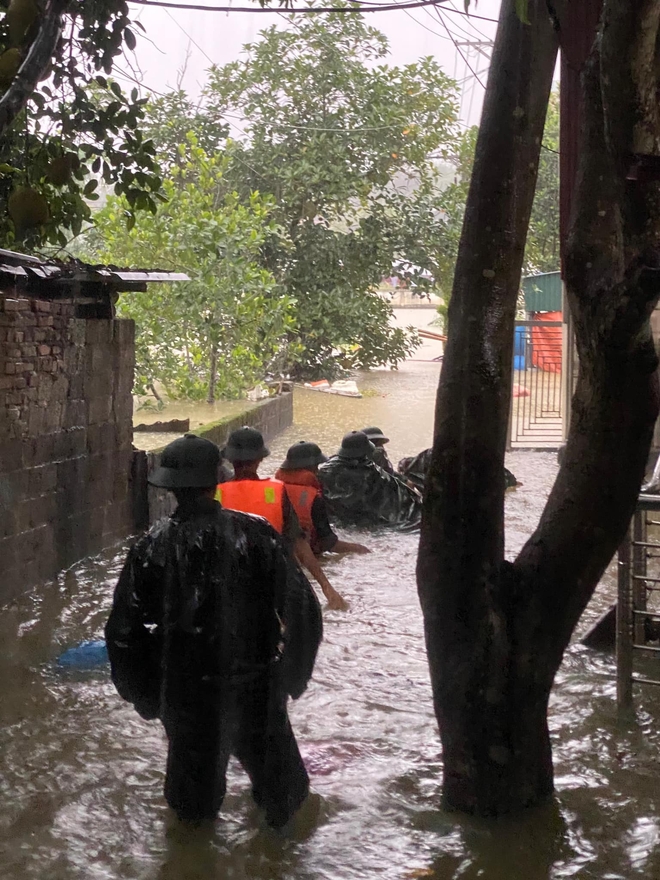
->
[509,320,565,449]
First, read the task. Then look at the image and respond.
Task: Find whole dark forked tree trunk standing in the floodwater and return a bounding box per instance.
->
[418,0,660,815]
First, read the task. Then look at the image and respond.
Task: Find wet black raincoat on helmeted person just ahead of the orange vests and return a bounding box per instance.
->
[318,455,422,530]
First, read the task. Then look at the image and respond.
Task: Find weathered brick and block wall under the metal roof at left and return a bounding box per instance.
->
[0,293,134,602]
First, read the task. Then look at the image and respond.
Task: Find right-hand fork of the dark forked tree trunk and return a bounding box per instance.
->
[515,0,660,652]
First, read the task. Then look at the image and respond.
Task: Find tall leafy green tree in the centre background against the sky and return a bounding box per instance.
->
[200,14,456,376]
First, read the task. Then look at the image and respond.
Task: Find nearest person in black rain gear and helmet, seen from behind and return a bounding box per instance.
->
[106,435,322,828]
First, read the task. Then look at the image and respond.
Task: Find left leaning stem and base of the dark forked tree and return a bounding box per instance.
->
[418,0,558,814]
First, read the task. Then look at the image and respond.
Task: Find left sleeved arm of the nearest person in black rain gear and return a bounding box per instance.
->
[105,547,160,719]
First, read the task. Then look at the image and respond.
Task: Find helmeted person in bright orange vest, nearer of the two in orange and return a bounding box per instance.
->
[216,426,348,611]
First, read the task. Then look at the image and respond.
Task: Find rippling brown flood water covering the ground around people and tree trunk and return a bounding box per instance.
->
[0,354,660,880]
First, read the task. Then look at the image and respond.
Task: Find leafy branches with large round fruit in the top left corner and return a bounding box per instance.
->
[0,0,161,248]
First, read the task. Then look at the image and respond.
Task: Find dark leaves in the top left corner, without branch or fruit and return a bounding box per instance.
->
[0,0,161,249]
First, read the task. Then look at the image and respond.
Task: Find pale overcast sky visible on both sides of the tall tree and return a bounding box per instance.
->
[124,0,500,124]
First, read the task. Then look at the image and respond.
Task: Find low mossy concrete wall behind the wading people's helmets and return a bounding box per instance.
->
[133,391,293,530]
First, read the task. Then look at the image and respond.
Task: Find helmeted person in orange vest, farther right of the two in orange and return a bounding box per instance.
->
[275,440,371,556]
